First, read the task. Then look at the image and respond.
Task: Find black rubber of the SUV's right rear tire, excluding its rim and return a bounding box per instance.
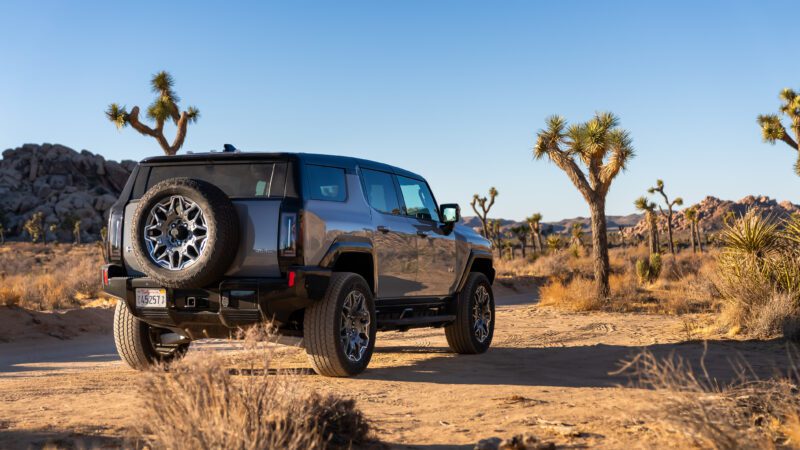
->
[303,272,378,377]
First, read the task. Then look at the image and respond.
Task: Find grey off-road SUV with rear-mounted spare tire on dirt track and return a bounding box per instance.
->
[102,151,495,376]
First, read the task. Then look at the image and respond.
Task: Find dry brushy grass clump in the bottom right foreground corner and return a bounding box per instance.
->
[617,351,800,450]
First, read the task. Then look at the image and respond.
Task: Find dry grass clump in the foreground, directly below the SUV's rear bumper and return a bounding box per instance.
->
[136,326,369,450]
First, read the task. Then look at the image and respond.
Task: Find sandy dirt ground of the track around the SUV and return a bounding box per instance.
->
[0,287,786,449]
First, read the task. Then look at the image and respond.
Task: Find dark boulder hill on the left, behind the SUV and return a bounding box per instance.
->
[0,144,136,241]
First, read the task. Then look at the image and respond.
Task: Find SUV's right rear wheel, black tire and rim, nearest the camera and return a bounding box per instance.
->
[303,272,377,377]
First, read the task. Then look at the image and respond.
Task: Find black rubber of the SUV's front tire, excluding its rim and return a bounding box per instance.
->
[444,272,495,354]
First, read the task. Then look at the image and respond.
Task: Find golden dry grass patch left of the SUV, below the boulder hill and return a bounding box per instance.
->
[0,243,103,311]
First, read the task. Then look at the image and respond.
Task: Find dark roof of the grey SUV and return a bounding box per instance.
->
[140,151,424,180]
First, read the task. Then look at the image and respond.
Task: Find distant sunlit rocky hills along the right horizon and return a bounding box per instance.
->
[625,195,800,236]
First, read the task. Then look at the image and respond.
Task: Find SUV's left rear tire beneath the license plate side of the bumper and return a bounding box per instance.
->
[114,300,189,370]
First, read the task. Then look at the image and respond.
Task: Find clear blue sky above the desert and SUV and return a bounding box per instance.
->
[0,1,800,220]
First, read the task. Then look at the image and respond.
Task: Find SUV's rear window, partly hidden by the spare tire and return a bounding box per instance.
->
[144,163,284,198]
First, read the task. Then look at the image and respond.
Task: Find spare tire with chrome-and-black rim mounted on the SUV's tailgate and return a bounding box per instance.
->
[131,178,239,288]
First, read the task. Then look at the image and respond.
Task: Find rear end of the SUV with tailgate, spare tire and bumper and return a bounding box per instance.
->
[103,153,314,344]
